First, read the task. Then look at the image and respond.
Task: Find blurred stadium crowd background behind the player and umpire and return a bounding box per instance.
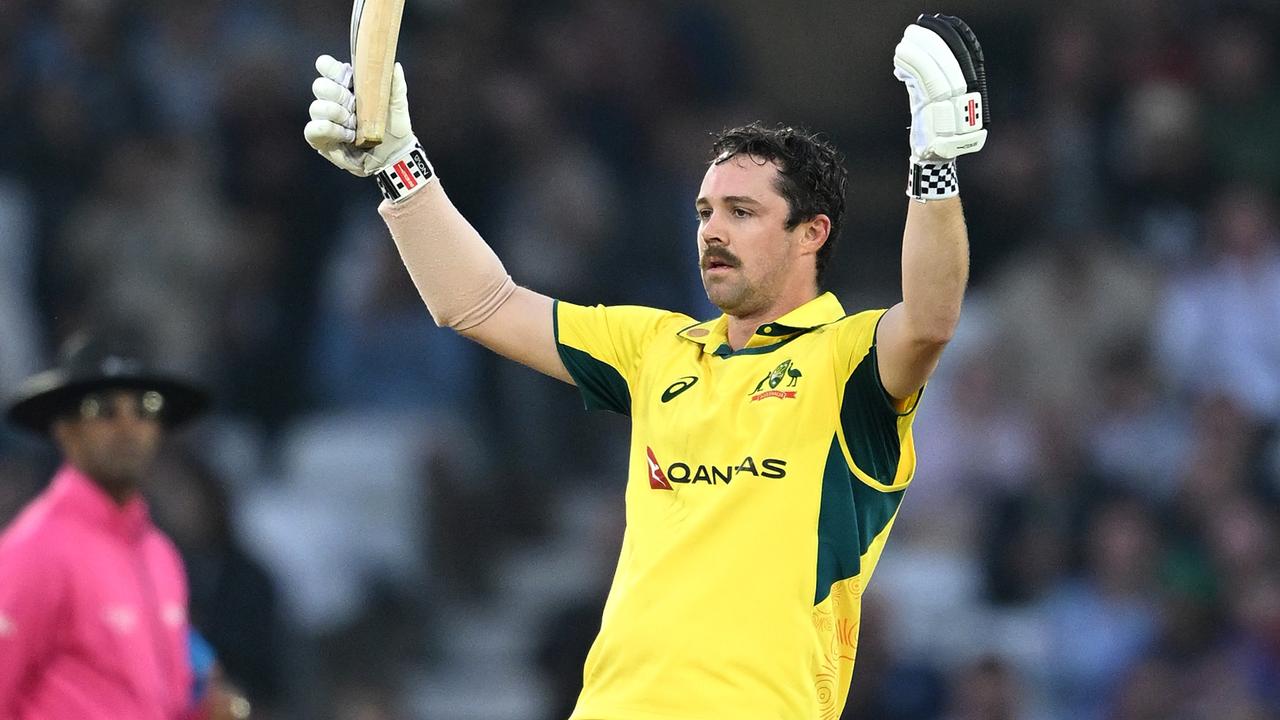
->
[0,0,1280,720]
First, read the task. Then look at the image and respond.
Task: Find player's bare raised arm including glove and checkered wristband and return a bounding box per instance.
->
[876,15,987,400]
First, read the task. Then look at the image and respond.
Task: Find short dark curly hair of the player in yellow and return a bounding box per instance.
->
[712,122,849,286]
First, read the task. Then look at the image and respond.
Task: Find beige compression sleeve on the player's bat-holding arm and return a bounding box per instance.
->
[378,181,516,332]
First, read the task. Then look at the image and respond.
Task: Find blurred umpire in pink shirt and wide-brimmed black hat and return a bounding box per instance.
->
[0,336,243,720]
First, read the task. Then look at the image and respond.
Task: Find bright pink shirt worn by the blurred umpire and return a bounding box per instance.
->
[0,465,192,720]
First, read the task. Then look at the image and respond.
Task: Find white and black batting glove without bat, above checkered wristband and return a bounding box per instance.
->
[893,15,989,200]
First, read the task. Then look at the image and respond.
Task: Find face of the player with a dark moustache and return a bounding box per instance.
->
[696,155,803,316]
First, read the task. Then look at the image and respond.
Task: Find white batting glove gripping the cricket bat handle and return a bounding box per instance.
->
[302,55,435,201]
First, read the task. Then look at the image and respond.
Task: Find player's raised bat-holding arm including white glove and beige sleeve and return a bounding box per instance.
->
[305,55,573,383]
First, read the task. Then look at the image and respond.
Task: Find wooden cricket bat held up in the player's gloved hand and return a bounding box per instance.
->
[351,0,404,149]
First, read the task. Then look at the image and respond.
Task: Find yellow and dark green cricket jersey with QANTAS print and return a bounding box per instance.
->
[554,293,918,720]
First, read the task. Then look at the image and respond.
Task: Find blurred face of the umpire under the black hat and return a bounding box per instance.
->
[54,389,164,498]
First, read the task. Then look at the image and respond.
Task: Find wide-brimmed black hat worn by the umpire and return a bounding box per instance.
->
[5,334,209,436]
